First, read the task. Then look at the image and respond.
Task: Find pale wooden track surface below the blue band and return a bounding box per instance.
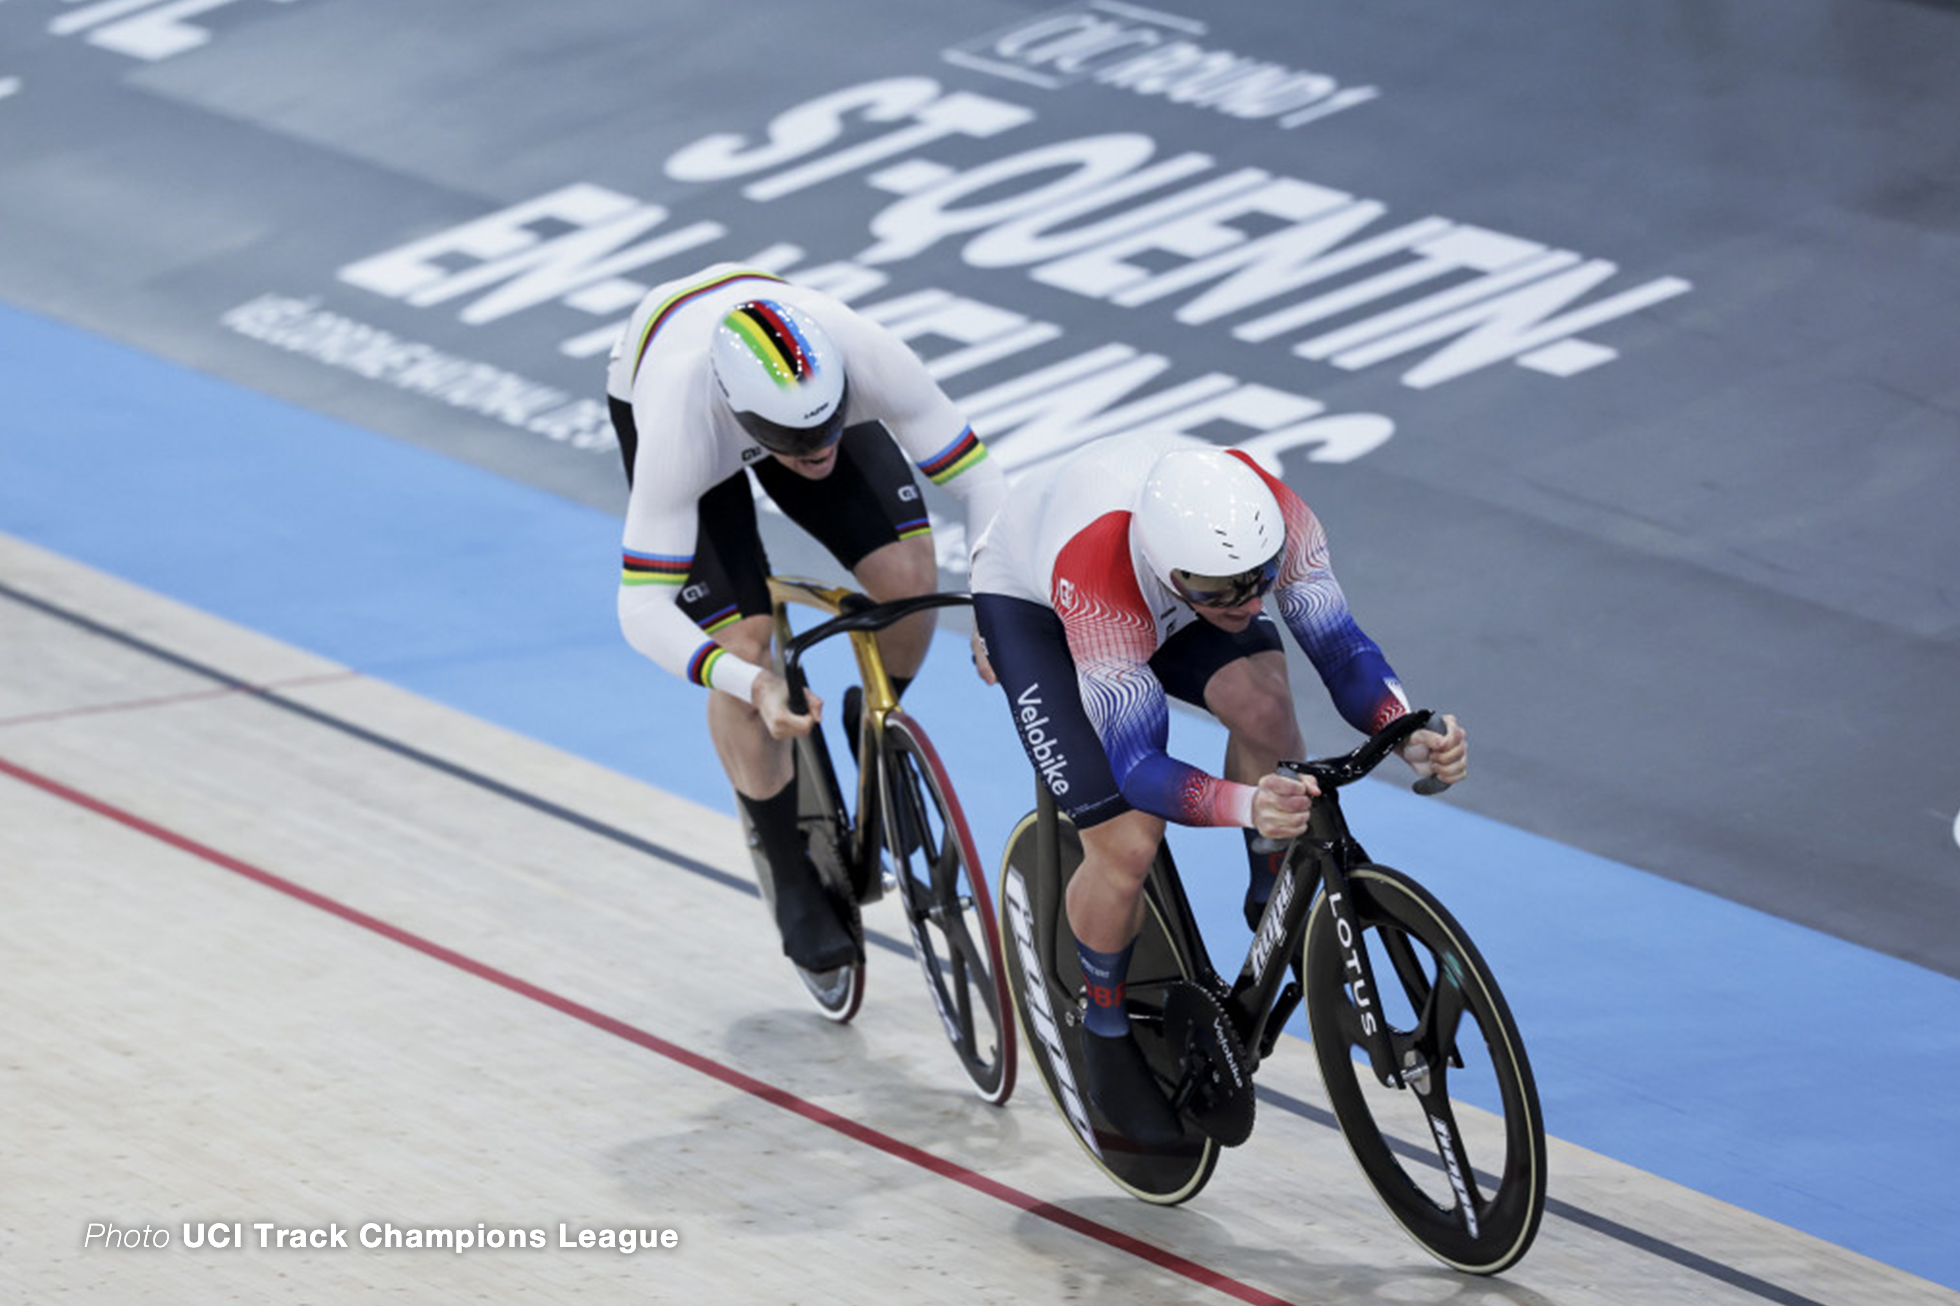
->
[0,535,1960,1306]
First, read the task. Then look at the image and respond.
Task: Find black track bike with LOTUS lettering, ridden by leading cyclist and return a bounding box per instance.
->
[1000,712,1546,1275]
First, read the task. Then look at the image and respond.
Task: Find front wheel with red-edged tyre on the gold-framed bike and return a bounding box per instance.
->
[884,710,1015,1106]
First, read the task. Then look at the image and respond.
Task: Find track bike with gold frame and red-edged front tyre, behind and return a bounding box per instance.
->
[745,577,1015,1104]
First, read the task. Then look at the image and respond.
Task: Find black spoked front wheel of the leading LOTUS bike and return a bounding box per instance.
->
[1301,865,1546,1275]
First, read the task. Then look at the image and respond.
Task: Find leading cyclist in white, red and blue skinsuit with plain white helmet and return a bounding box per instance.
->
[972,435,1468,1145]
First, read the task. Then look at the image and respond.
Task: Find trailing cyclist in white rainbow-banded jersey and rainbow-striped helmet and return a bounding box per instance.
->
[606,263,1004,971]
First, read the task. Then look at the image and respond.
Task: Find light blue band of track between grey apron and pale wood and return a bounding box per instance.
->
[0,308,1960,1288]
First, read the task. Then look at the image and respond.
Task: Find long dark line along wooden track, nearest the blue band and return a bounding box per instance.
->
[0,580,1834,1306]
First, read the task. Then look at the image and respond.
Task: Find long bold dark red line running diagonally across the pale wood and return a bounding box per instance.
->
[0,757,1290,1306]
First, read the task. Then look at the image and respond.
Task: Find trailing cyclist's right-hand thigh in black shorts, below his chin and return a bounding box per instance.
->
[755,422,933,571]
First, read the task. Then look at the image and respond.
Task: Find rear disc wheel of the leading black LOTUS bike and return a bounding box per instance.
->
[1000,812,1219,1206]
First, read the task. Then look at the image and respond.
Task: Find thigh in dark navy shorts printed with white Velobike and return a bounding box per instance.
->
[974,594,1131,829]
